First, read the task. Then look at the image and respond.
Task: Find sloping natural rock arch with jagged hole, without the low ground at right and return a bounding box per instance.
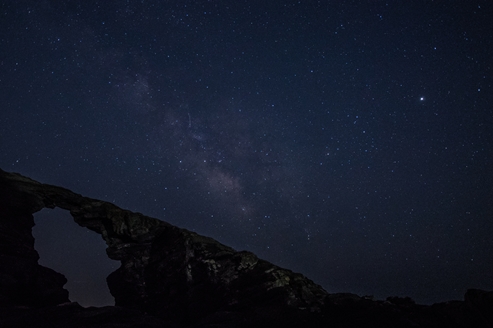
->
[0,170,327,324]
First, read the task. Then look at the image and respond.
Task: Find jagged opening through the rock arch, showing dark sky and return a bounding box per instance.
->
[33,208,120,307]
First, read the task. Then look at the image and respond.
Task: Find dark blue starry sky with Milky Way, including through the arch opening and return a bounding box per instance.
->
[0,0,493,304]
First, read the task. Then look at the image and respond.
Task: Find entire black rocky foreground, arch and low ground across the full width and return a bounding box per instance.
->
[0,170,493,327]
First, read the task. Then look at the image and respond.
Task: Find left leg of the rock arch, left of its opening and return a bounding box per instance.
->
[0,171,68,306]
